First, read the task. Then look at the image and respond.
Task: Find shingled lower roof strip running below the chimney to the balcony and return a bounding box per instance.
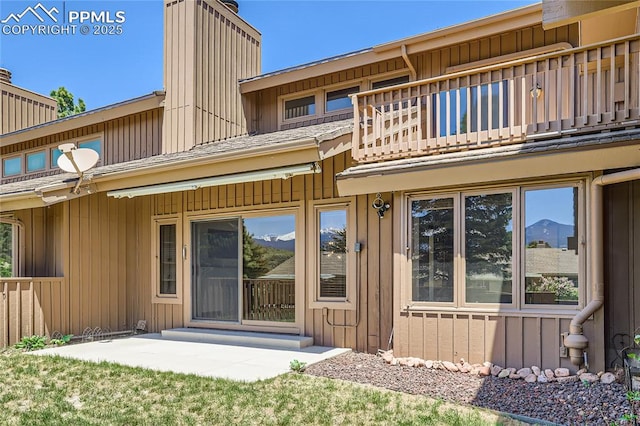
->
[0,119,353,195]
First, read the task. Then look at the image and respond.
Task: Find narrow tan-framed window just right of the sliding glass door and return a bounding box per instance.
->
[309,203,356,309]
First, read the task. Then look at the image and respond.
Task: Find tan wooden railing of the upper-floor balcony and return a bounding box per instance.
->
[352,35,640,162]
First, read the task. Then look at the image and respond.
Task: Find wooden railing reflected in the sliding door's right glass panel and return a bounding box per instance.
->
[242,279,296,321]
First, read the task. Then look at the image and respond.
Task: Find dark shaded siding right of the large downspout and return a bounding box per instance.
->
[604,181,640,367]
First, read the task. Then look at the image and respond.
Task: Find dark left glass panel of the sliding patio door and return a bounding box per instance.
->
[191,218,240,322]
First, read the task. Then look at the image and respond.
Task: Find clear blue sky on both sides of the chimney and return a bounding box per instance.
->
[0,0,535,109]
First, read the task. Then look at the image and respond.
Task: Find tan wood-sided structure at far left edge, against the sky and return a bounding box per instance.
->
[0,83,58,134]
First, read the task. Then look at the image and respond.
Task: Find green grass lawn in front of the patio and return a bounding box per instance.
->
[0,350,510,426]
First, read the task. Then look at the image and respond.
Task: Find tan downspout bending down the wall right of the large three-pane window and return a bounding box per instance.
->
[564,168,640,366]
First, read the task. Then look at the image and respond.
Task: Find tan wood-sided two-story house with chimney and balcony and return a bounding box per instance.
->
[0,0,640,370]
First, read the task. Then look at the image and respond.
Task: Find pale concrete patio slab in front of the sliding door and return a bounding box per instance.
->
[32,333,351,382]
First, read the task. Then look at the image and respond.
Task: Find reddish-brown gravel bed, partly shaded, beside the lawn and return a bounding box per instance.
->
[305,352,631,425]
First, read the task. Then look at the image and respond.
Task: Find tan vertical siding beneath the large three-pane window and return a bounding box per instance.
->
[394,310,602,370]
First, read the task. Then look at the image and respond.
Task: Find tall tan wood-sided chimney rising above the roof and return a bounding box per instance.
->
[163,0,260,152]
